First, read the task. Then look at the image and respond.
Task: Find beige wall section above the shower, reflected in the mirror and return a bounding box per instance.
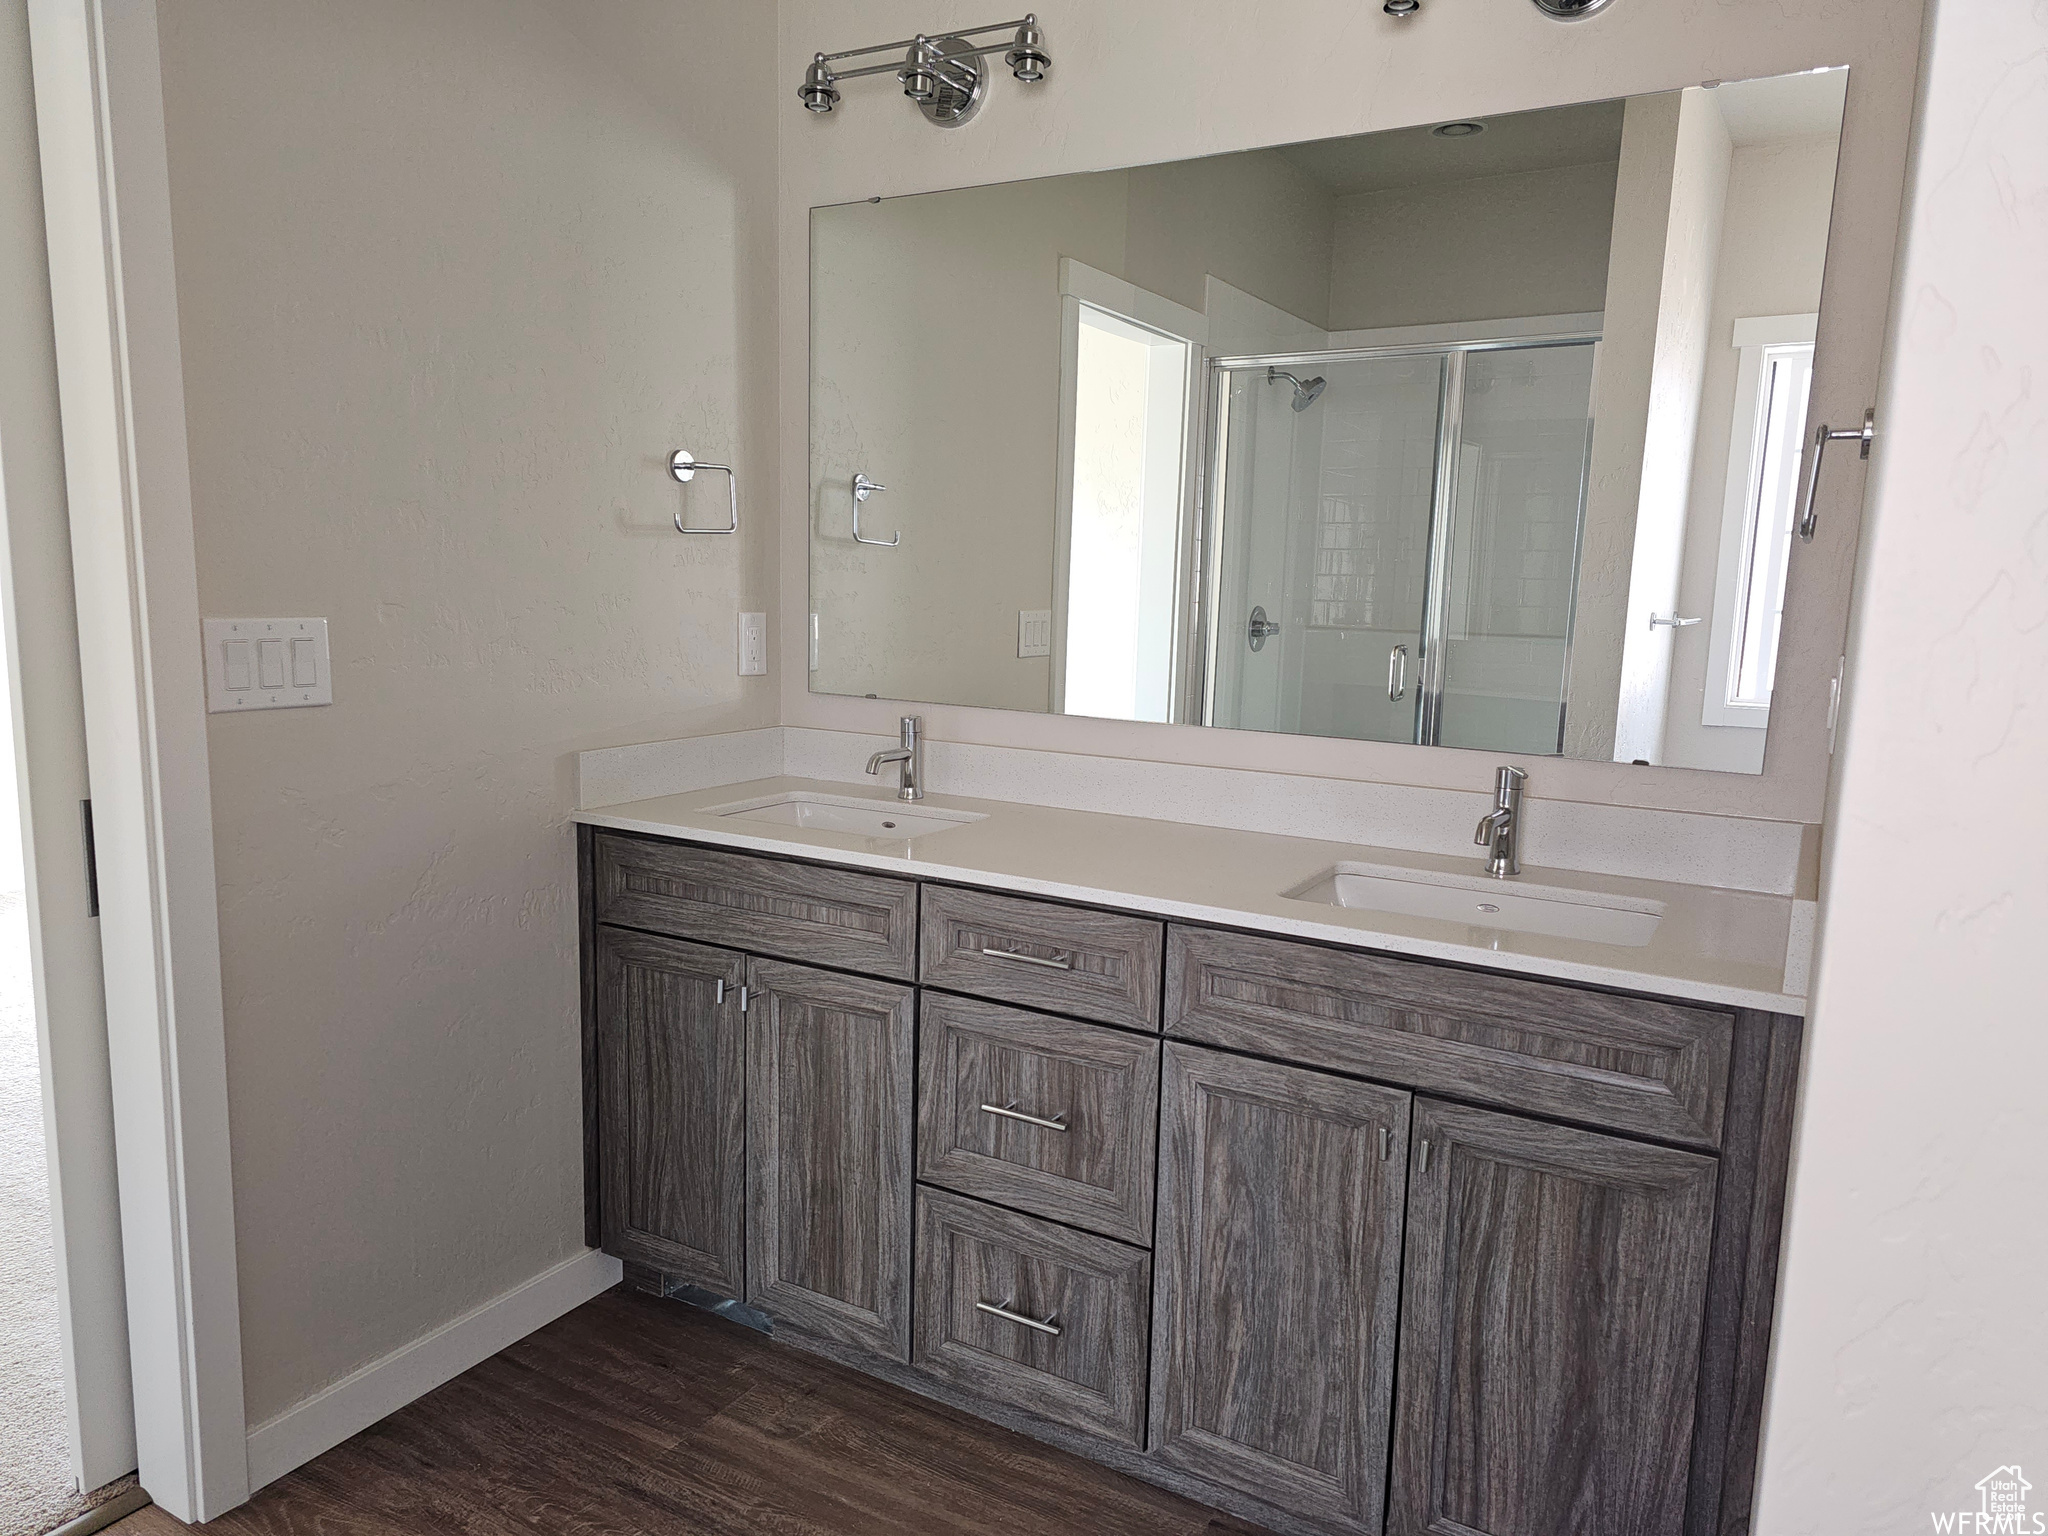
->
[1329,162,1616,330]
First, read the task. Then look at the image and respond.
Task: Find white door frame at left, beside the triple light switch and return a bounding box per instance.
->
[29,0,248,1522]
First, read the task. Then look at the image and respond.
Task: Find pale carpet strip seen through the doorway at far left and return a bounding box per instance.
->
[0,891,127,1536]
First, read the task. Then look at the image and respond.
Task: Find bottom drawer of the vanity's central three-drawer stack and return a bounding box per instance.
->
[911,1188,1151,1446]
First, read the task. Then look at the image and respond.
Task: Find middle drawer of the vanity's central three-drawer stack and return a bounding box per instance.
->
[918,991,1159,1243]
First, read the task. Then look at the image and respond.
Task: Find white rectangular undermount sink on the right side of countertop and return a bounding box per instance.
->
[1282,864,1663,948]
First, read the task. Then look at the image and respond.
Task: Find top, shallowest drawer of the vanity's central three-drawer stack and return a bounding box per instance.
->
[922,885,1163,1030]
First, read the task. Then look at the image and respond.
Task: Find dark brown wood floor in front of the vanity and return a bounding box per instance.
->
[113,1288,1255,1536]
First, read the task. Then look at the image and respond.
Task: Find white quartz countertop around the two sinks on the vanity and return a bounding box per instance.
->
[573,778,1806,1014]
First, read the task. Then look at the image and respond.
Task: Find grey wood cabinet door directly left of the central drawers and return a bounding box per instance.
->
[748,961,913,1360]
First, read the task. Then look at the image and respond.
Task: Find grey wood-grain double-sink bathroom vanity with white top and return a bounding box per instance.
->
[580,780,1802,1536]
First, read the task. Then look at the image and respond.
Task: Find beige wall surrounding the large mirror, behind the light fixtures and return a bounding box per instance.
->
[776,0,1923,821]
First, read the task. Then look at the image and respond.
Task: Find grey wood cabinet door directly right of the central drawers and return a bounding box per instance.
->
[1151,1044,1409,1532]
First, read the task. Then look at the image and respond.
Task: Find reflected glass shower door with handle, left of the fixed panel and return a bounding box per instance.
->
[1206,354,1446,741]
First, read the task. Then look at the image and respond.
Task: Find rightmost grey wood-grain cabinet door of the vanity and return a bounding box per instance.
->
[1391,1100,1716,1536]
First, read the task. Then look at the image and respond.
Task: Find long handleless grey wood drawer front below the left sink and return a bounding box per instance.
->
[596,838,918,981]
